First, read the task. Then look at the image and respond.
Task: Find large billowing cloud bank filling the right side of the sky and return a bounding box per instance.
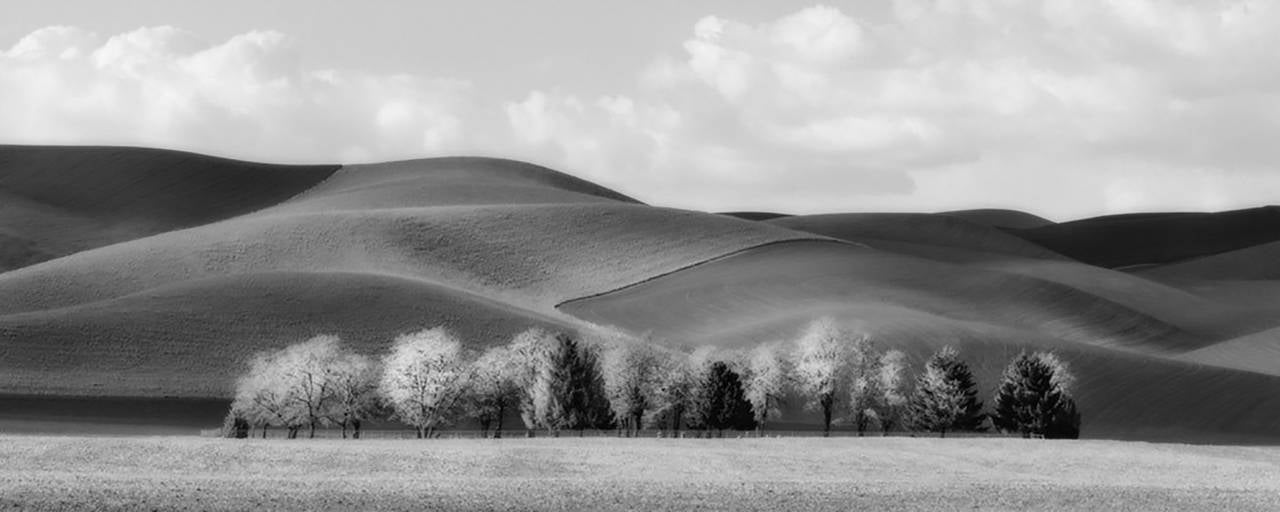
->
[508,0,1280,218]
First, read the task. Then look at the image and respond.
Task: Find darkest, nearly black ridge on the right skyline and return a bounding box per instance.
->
[1010,206,1280,269]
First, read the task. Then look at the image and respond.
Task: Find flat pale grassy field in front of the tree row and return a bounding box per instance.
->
[0,436,1280,511]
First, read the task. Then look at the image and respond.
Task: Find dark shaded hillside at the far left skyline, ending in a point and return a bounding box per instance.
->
[0,145,338,271]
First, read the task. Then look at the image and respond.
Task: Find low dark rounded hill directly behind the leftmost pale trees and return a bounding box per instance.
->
[0,273,573,397]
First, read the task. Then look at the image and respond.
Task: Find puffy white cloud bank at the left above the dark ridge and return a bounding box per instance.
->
[0,27,476,161]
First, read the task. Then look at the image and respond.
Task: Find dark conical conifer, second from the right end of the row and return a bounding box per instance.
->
[909,347,986,436]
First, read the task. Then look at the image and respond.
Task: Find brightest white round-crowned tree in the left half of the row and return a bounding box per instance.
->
[379,328,471,439]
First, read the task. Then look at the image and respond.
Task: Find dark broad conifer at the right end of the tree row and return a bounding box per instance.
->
[992,352,1080,439]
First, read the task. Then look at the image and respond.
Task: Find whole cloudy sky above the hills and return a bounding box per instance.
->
[0,0,1280,220]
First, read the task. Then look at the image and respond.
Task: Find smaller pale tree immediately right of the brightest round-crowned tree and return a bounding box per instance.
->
[467,346,522,439]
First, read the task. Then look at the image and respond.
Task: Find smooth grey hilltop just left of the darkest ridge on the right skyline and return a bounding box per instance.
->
[768,214,1064,260]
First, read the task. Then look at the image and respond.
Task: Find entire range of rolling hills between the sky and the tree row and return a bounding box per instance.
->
[0,146,1280,440]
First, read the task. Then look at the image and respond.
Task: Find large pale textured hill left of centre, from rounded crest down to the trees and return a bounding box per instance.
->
[0,149,815,397]
